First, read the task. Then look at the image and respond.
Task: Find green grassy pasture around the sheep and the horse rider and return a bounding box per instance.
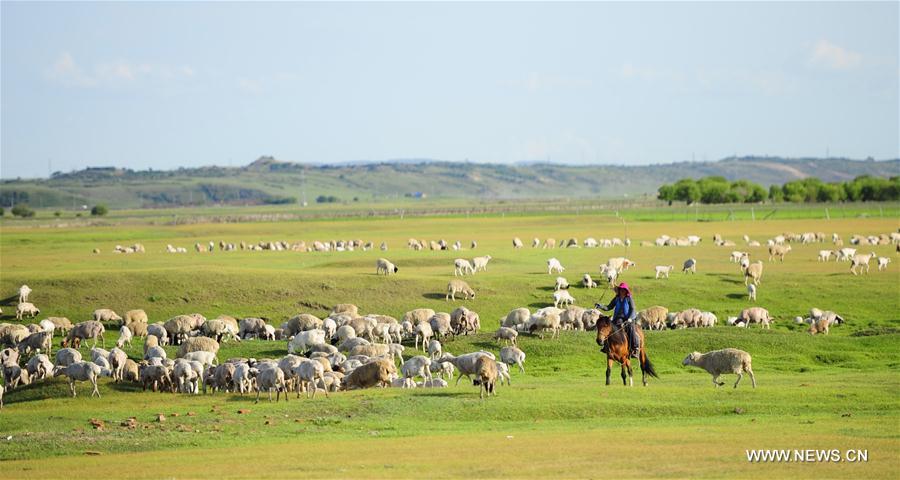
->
[0,205,900,478]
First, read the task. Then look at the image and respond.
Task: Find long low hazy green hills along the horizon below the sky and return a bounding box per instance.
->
[0,157,900,208]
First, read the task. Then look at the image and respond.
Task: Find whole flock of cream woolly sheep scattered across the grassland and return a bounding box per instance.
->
[0,227,900,407]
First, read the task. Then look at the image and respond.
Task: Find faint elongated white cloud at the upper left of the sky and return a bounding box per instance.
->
[47,52,195,88]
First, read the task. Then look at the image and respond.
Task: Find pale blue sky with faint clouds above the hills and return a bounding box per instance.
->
[0,2,900,178]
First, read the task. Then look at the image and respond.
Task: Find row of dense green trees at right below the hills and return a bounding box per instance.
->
[658,175,900,205]
